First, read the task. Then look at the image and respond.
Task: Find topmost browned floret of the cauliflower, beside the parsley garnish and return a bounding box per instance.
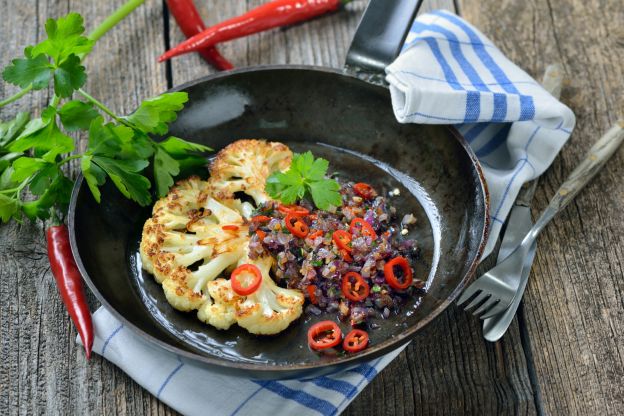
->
[208,140,292,204]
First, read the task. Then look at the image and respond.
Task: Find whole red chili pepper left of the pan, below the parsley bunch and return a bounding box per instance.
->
[46,225,93,359]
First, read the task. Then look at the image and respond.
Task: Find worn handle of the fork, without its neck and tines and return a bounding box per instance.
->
[522,120,624,240]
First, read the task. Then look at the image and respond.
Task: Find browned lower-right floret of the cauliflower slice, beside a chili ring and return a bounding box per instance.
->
[236,256,304,335]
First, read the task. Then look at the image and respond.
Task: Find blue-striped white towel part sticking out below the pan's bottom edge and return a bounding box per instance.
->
[76,307,403,416]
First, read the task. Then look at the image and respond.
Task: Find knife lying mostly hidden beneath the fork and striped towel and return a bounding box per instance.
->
[483,65,563,342]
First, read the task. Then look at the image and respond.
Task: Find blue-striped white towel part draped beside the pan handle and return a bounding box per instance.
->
[386,10,575,256]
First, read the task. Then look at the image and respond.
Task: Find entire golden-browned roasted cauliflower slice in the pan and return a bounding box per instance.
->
[140,140,304,334]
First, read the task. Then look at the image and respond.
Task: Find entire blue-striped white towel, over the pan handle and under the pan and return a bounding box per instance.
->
[77,11,574,416]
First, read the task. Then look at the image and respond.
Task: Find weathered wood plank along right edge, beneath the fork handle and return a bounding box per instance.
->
[463,0,624,415]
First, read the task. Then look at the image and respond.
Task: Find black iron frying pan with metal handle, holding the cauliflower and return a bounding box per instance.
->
[69,0,488,378]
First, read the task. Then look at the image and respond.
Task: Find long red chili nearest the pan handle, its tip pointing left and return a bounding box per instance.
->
[158,0,350,62]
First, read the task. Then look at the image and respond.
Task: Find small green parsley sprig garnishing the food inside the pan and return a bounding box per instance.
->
[266,151,342,210]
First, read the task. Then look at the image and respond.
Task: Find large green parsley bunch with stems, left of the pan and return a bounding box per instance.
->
[0,0,211,222]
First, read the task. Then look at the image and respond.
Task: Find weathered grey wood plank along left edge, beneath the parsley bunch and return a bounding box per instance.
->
[0,0,171,414]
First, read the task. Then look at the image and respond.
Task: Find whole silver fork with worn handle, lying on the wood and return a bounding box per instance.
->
[457,120,624,319]
